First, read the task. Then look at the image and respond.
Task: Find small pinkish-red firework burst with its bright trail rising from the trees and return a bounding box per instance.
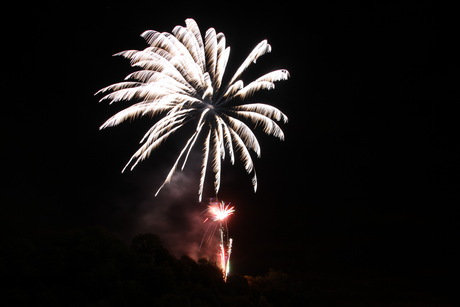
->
[202,200,235,281]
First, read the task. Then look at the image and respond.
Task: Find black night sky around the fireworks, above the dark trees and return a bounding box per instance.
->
[1,1,460,304]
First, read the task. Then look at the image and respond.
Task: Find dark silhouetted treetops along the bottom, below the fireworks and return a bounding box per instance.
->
[0,228,304,307]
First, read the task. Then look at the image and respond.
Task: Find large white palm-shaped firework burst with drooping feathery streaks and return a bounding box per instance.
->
[96,19,289,201]
